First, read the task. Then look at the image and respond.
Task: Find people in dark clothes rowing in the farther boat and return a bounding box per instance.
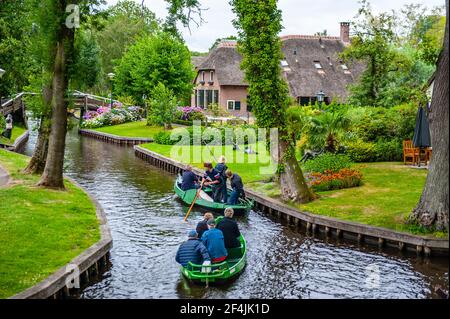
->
[181,156,245,205]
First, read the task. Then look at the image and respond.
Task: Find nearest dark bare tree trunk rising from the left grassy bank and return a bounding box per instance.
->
[38,26,74,189]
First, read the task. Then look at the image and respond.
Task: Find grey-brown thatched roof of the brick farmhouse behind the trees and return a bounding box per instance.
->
[197,35,364,98]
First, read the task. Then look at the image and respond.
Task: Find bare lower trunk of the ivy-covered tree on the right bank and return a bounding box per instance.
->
[279,136,315,203]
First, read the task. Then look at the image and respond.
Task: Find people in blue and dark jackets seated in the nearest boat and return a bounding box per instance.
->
[175,207,241,267]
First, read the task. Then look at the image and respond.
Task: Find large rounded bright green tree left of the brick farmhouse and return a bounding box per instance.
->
[114,32,195,101]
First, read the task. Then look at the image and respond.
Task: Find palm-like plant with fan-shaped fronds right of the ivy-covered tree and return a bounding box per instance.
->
[308,111,350,153]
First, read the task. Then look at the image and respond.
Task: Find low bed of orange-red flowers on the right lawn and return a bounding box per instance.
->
[306,168,362,192]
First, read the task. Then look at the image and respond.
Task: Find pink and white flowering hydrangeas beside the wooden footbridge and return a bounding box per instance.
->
[81,103,143,128]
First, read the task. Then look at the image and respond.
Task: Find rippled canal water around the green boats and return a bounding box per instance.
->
[24,128,448,299]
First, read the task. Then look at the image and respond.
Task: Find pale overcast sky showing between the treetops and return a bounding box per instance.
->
[107,0,445,52]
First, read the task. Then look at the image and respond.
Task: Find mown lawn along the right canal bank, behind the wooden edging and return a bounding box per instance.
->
[142,143,448,237]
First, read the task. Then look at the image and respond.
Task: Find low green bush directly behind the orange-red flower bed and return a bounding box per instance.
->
[303,153,352,173]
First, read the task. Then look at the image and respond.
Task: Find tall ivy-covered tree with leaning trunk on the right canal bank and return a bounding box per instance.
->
[231,0,313,202]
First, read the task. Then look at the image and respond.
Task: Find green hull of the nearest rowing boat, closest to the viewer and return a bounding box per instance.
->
[181,216,247,284]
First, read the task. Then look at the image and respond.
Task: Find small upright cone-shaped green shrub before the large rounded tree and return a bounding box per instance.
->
[147,82,177,129]
